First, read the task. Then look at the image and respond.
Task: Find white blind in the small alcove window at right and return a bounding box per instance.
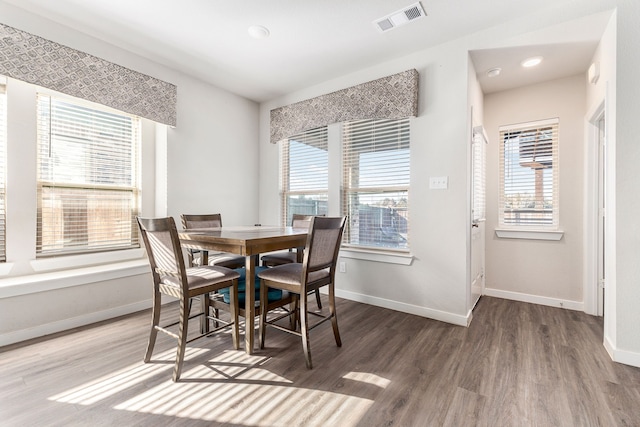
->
[499,119,559,228]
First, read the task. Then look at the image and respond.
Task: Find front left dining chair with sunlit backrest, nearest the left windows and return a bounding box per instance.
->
[137,217,240,381]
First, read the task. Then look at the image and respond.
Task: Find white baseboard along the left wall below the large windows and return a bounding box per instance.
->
[0,297,170,347]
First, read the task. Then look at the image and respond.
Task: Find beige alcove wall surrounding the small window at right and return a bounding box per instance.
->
[484,74,586,309]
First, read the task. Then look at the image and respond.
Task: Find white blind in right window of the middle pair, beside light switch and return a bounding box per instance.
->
[342,118,410,250]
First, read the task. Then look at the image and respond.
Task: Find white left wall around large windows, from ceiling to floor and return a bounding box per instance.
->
[0,4,258,346]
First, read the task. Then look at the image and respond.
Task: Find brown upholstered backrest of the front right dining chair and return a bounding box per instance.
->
[303,216,346,281]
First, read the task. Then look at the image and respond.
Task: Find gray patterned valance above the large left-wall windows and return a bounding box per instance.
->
[0,24,177,126]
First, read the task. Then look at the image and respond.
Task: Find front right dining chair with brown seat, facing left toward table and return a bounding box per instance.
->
[258,217,345,369]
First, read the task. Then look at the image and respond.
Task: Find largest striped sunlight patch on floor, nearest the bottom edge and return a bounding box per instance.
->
[114,366,373,426]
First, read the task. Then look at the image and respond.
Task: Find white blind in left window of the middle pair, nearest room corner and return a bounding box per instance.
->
[280,126,329,225]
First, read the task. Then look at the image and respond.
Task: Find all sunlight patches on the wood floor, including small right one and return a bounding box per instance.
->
[49,347,389,426]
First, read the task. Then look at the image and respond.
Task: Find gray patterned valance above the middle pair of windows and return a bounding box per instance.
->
[271,70,418,143]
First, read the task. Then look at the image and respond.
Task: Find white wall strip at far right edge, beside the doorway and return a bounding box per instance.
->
[605,0,640,366]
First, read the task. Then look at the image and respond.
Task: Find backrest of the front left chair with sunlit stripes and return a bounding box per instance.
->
[137,217,187,291]
